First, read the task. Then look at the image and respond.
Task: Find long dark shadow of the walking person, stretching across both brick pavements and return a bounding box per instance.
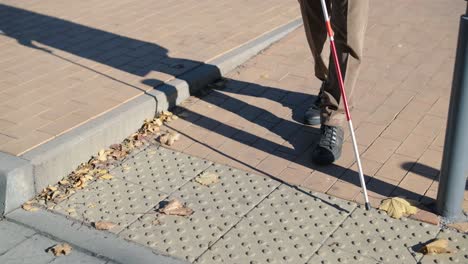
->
[0,4,436,207]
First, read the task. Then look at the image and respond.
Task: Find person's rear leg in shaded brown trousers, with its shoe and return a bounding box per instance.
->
[299,0,331,125]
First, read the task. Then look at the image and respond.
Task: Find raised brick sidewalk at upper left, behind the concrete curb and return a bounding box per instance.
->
[0,0,299,155]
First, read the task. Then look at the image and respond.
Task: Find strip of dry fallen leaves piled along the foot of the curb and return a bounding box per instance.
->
[22,111,179,211]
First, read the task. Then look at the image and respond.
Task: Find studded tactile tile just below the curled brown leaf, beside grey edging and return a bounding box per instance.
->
[119,208,240,262]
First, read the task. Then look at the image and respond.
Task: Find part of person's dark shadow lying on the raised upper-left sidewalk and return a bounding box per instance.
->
[0,4,212,98]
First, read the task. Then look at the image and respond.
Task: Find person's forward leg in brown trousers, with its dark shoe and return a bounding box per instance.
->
[313,0,369,164]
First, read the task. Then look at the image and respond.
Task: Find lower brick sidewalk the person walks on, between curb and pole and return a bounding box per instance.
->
[163,0,468,214]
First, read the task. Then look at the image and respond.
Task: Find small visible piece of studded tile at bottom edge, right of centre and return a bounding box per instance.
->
[307,246,381,264]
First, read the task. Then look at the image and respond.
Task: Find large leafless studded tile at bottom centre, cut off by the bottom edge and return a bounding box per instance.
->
[195,219,320,264]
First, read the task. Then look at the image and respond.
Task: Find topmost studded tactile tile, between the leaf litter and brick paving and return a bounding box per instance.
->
[112,145,212,193]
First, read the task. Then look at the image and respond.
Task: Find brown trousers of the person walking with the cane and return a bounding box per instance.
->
[299,0,369,126]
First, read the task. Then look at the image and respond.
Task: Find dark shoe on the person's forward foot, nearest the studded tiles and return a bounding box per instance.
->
[312,125,344,165]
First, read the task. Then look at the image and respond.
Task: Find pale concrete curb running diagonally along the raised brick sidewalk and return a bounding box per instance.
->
[0,18,302,214]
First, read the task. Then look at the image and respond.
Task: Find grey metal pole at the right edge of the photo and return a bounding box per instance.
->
[437,2,468,222]
